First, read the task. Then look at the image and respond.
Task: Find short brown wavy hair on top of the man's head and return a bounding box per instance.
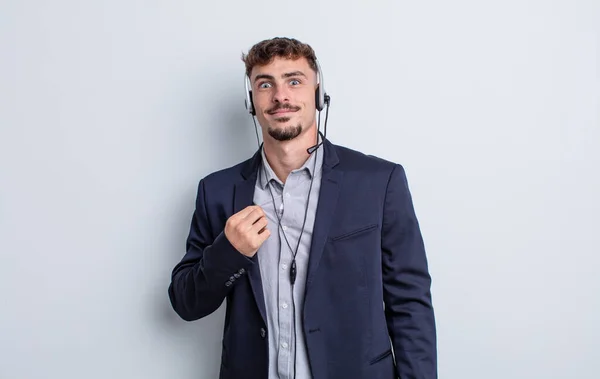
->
[242,37,318,77]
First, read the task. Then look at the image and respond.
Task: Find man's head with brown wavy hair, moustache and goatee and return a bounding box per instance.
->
[242,38,318,141]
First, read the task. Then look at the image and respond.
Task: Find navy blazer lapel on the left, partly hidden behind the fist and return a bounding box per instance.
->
[233,146,267,325]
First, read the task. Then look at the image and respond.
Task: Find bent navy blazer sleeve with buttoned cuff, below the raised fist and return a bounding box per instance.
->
[168,180,254,321]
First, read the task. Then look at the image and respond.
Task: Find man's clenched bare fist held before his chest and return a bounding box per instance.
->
[225,205,271,257]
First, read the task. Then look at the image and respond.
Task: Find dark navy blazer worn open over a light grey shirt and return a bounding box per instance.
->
[169,140,437,379]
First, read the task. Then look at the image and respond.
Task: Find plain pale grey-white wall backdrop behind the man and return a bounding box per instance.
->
[0,0,600,379]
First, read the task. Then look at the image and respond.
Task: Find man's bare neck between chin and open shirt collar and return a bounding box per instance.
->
[263,126,317,183]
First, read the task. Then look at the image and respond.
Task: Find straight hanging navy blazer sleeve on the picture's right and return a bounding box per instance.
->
[382,165,437,379]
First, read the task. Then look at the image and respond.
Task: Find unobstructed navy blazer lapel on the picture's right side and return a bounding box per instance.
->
[306,140,343,291]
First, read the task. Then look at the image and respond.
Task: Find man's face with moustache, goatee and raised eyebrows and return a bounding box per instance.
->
[250,57,317,141]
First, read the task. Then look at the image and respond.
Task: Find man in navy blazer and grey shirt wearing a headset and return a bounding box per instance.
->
[169,38,437,379]
